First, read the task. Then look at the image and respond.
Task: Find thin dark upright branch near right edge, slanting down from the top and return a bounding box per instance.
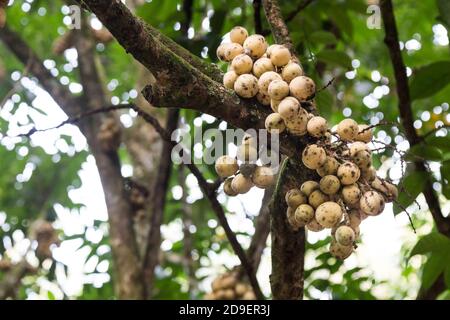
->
[380,0,450,236]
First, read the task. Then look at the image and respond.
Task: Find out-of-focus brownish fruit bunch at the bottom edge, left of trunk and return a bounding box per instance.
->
[204,271,256,300]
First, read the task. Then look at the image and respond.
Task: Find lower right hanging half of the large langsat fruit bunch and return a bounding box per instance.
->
[285,118,398,259]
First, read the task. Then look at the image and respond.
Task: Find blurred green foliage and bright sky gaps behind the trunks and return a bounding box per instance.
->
[0,0,450,299]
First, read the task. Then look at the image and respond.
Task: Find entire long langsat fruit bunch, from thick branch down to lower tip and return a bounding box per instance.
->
[216,27,398,259]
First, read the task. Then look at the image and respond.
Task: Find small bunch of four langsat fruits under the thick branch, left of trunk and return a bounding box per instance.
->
[215,134,275,197]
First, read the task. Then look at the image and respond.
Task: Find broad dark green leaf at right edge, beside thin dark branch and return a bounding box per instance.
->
[410,61,450,100]
